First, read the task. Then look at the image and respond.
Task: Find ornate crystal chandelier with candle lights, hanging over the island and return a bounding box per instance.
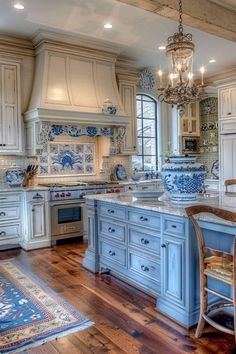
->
[158,0,205,116]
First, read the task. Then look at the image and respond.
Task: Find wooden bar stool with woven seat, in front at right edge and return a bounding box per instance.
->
[185,205,236,340]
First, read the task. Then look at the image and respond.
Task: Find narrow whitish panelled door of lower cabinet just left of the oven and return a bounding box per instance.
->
[31,203,46,238]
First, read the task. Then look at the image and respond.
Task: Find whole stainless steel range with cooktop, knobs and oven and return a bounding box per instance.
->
[38,181,124,244]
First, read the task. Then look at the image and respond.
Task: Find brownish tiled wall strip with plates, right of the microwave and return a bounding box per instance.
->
[198,97,219,178]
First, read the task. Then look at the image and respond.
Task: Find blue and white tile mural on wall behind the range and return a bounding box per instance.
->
[39,143,95,175]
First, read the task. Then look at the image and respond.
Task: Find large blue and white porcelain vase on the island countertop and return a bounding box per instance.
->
[161,156,206,202]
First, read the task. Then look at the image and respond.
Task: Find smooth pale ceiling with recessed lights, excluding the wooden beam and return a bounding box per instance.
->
[0,0,236,75]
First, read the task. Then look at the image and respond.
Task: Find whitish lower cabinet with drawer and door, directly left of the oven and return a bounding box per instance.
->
[21,191,51,250]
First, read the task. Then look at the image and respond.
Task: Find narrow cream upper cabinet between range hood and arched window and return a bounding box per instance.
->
[118,74,137,155]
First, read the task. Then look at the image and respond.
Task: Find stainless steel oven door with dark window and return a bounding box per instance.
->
[51,201,84,239]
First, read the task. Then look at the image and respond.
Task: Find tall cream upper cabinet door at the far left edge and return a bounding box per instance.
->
[0,62,22,155]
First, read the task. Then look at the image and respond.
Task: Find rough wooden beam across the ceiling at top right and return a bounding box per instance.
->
[116,0,236,42]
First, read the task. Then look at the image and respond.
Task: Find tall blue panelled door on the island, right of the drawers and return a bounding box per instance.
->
[161,235,185,306]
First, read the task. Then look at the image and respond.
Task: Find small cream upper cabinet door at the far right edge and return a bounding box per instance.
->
[219,85,236,118]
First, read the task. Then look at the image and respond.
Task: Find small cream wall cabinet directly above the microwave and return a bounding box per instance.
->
[180,102,200,136]
